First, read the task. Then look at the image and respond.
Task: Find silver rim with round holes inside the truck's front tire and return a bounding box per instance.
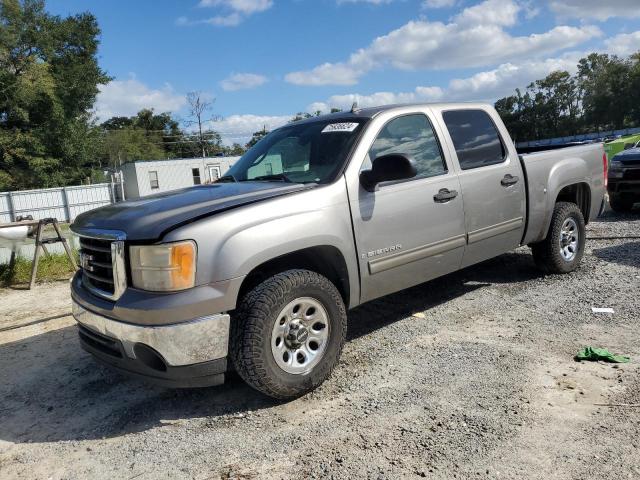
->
[271,297,330,375]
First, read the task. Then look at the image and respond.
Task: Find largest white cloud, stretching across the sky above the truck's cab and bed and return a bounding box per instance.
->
[285,0,602,86]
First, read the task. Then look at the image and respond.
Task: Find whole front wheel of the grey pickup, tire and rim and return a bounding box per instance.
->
[230,270,347,399]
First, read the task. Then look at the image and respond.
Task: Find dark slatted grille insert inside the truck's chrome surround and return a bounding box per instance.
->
[80,237,115,296]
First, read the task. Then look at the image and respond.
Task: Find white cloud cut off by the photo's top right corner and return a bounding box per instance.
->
[549,0,640,21]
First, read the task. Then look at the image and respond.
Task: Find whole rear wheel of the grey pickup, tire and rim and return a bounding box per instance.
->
[531,202,586,273]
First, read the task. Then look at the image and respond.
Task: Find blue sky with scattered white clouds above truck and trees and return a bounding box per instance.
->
[47,0,640,143]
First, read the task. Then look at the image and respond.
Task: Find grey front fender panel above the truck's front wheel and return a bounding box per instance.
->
[164,181,360,310]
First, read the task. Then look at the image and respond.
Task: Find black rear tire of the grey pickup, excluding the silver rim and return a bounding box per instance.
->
[531,202,586,273]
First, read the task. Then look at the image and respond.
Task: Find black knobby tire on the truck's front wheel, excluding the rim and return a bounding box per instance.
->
[229,270,347,400]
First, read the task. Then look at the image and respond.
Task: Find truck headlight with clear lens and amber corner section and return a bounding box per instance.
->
[129,240,196,292]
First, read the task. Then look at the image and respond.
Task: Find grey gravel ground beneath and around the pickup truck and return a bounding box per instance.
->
[0,213,640,479]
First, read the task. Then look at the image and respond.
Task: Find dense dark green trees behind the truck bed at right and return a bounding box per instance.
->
[495,51,640,141]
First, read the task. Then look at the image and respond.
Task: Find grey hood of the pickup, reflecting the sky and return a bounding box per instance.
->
[71,182,313,240]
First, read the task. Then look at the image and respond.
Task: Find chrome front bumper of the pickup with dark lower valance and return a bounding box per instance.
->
[72,301,229,387]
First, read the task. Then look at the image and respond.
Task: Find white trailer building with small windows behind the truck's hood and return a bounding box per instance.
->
[122,157,240,200]
